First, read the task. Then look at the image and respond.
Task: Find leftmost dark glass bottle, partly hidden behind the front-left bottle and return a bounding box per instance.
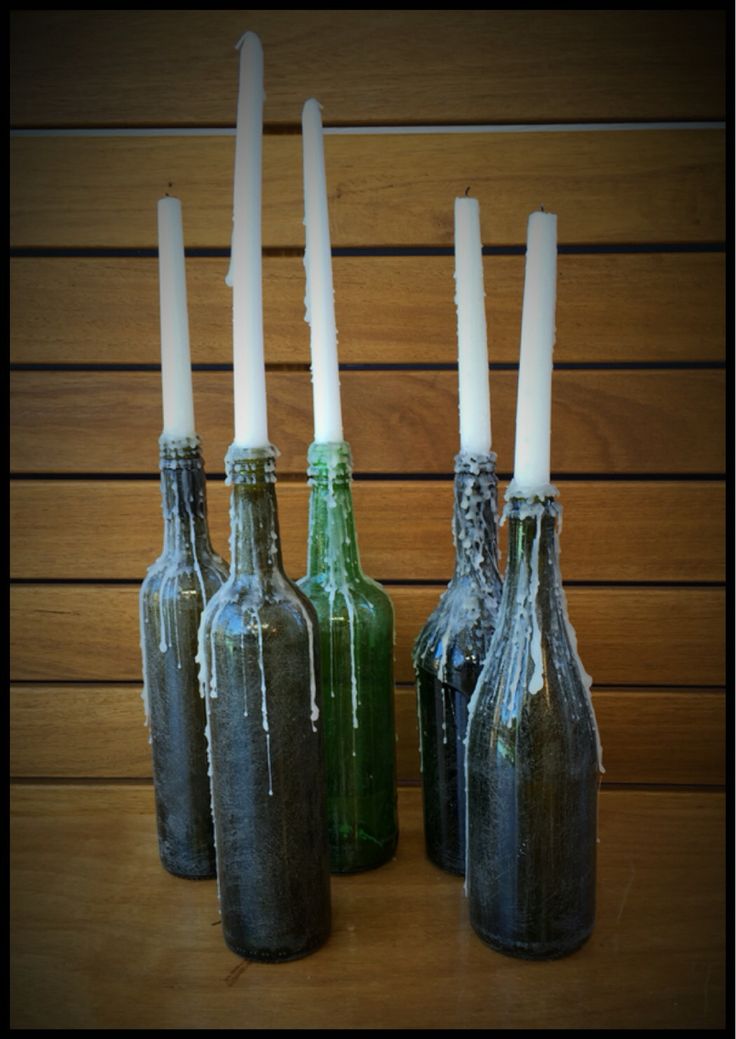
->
[139,436,228,879]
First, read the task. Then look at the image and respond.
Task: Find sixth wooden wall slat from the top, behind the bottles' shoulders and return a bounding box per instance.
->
[10,584,726,686]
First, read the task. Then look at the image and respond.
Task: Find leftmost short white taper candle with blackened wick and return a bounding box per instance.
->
[158,196,194,437]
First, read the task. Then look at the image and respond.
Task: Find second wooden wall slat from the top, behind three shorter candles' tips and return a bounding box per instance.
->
[10,130,725,247]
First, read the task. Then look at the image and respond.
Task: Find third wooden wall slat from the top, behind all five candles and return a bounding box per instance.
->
[10,252,726,364]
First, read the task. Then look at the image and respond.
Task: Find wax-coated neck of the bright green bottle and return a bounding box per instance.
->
[307,441,363,584]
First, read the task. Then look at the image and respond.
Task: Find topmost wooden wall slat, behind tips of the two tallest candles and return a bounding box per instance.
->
[10,10,725,126]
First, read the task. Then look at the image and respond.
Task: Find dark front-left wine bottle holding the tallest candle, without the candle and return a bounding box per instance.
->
[199,445,331,962]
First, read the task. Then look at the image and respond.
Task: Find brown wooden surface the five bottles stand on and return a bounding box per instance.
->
[10,783,726,1030]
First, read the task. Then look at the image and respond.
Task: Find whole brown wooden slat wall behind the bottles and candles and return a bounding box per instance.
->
[10,10,726,787]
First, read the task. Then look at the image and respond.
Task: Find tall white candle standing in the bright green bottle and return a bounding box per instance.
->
[301,98,343,444]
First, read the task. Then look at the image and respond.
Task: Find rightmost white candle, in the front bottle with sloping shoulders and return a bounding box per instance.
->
[514,212,557,497]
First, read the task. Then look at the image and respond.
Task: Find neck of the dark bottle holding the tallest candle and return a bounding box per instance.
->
[225,444,283,577]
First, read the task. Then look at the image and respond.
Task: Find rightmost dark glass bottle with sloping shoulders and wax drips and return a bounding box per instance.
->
[467,498,601,959]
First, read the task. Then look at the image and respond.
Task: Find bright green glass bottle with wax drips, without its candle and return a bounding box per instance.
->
[299,443,398,873]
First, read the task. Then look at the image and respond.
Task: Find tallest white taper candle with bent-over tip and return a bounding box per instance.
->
[228,32,268,448]
